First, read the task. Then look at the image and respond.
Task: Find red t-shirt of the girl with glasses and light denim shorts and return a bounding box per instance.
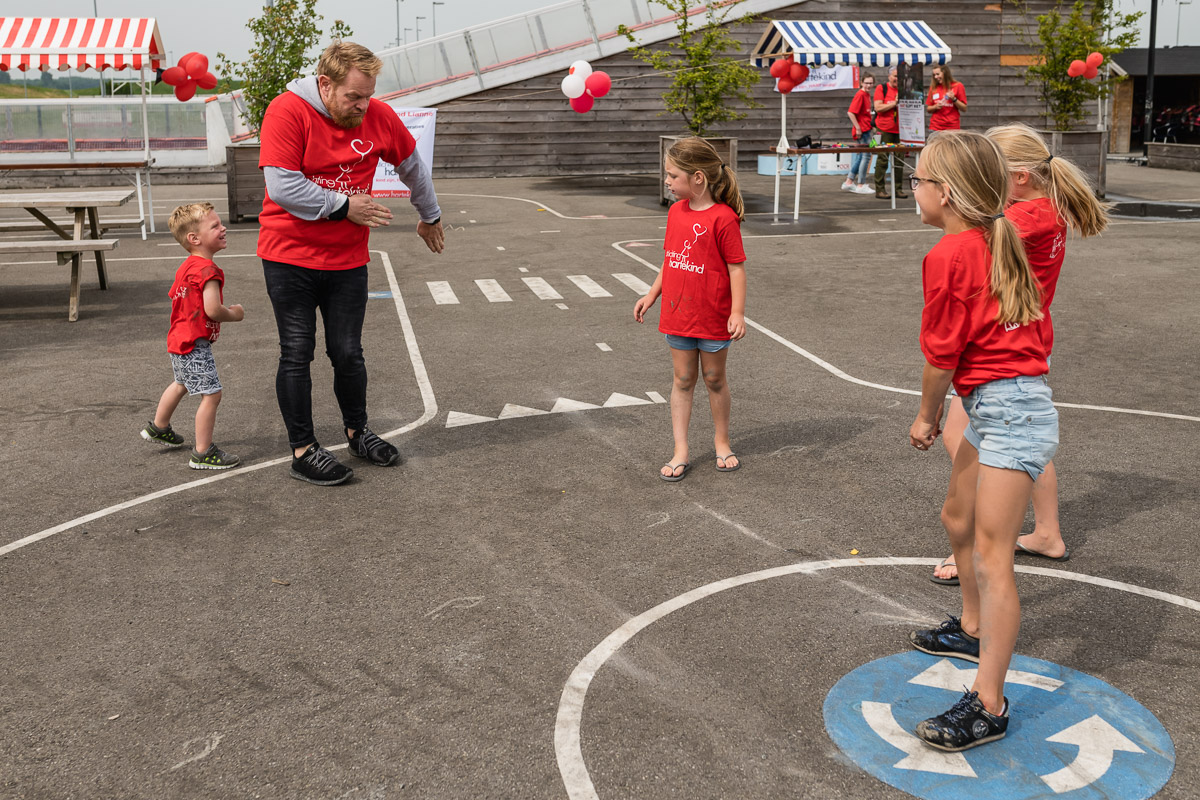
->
[920,228,1048,397]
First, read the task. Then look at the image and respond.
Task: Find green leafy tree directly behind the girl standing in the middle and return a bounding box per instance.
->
[617,0,761,136]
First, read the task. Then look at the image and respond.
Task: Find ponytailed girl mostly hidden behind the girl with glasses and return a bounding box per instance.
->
[932,125,1109,585]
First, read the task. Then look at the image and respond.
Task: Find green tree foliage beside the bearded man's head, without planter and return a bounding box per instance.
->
[217,0,353,131]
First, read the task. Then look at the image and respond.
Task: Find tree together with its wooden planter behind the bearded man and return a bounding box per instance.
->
[217,0,353,222]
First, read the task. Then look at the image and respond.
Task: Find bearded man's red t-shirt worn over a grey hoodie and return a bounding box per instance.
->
[258,91,416,270]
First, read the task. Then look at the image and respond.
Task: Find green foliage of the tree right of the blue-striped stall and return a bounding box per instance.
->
[1008,0,1137,131]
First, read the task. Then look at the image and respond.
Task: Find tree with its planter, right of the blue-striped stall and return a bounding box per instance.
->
[1009,0,1141,197]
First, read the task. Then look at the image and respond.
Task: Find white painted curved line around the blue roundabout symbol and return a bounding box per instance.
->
[554,557,1200,800]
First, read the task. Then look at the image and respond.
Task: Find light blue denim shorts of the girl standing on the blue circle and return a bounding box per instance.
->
[962,375,1058,481]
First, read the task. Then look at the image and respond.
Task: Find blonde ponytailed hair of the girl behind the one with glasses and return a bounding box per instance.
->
[986,122,1112,239]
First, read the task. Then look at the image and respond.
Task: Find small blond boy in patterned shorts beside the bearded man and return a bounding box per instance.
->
[142,203,246,469]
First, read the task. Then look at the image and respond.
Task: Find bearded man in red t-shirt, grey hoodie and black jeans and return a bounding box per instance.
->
[258,42,445,486]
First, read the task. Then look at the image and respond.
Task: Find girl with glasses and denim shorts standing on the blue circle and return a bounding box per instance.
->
[908,131,1058,751]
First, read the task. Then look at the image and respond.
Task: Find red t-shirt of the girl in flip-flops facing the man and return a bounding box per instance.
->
[659,200,746,341]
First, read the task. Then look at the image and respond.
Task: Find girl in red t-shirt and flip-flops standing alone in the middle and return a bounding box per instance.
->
[634,137,746,482]
